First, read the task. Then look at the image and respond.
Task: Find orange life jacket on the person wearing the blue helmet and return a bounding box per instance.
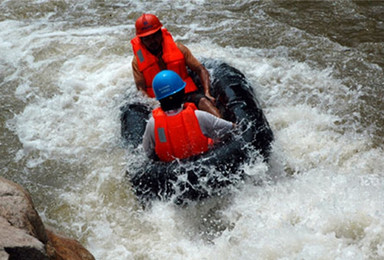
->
[152,103,213,162]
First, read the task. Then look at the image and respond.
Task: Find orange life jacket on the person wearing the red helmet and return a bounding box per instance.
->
[131,28,197,97]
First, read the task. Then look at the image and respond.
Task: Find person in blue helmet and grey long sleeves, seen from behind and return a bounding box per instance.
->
[143,70,235,162]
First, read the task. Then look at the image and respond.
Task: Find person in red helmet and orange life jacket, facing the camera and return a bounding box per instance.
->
[131,14,221,117]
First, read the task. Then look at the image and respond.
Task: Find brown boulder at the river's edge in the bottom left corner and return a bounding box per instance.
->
[0,177,95,260]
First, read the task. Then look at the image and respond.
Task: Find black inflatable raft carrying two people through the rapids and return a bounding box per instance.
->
[121,60,273,203]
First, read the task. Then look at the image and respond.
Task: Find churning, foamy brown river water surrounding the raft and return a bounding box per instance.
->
[0,0,384,259]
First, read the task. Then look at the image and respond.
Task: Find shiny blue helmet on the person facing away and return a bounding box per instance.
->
[152,70,187,100]
